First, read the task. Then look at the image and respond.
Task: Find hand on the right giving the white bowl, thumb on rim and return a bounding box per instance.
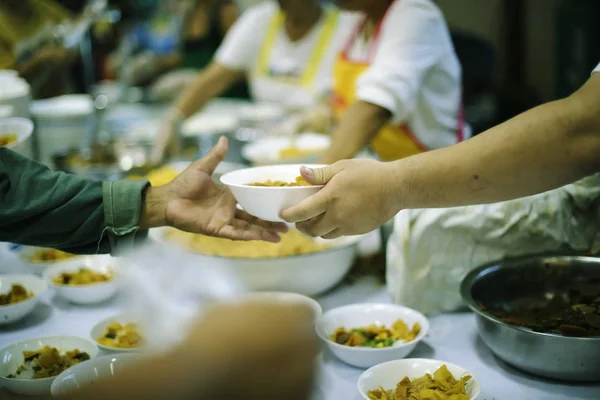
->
[281,159,398,239]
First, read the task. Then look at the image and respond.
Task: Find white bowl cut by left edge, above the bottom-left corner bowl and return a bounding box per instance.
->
[0,274,48,325]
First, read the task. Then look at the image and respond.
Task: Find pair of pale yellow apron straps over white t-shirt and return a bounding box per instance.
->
[255,9,339,88]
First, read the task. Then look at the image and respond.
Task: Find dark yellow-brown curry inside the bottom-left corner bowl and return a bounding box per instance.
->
[7,346,90,379]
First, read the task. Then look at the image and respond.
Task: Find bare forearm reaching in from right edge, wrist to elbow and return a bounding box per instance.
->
[394,91,600,208]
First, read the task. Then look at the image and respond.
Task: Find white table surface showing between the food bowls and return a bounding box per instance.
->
[0,264,600,400]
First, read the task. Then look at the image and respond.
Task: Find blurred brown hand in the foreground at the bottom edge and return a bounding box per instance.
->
[179,302,317,400]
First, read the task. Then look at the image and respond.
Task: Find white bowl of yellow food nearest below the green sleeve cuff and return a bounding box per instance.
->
[43,256,118,304]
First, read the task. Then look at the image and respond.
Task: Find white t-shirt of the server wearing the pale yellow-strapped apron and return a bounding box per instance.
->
[215,1,359,107]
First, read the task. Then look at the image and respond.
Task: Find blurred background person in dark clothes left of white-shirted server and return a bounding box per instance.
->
[111,0,244,95]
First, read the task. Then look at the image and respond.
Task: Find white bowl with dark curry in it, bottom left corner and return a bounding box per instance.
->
[0,336,98,396]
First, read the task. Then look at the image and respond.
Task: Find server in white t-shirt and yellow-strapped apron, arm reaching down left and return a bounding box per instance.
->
[153,0,358,161]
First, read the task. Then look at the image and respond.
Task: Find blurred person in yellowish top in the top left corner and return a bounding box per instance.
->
[0,0,76,97]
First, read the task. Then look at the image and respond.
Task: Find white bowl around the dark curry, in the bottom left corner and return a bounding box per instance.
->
[0,336,98,396]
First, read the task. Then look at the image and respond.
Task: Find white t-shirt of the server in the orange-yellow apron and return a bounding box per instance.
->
[347,0,462,149]
